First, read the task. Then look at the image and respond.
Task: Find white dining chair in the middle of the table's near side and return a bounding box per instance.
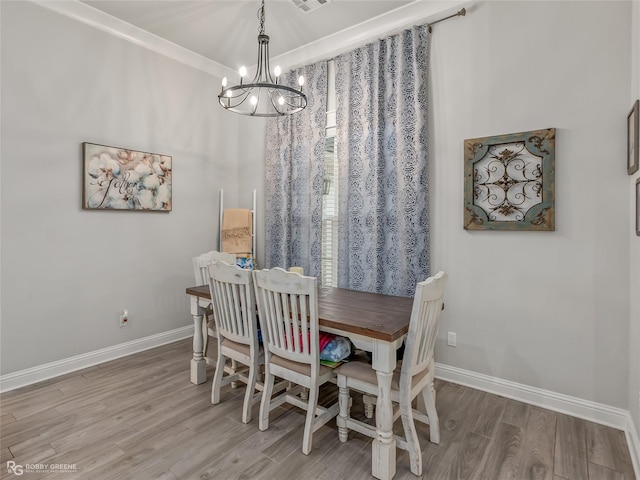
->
[253,268,339,455]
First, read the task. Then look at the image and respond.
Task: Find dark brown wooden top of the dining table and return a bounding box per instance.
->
[186,285,413,342]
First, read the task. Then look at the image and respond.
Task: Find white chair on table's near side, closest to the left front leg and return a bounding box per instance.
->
[208,261,264,423]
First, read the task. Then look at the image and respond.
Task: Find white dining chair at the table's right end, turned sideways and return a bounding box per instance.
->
[336,271,448,476]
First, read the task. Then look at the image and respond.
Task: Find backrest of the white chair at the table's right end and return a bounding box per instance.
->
[401,272,448,388]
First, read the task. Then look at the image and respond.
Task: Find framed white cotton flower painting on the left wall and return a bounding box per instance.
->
[82,142,171,212]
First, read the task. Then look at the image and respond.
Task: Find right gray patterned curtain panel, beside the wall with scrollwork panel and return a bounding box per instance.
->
[336,25,430,296]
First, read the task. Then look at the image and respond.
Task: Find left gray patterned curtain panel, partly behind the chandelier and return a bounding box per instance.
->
[265,61,327,278]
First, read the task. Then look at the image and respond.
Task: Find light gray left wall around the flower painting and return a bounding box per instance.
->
[0,1,245,374]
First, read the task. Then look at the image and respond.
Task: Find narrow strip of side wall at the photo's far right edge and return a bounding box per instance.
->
[627,1,640,442]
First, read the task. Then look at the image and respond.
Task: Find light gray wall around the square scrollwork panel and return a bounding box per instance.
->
[431,1,631,408]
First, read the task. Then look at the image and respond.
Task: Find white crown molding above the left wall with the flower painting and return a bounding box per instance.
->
[31,0,235,78]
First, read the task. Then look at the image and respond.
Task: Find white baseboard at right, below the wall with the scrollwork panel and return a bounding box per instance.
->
[435,363,640,479]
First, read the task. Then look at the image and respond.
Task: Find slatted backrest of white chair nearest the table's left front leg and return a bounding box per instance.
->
[208,261,258,345]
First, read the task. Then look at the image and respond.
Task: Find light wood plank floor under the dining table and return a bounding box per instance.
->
[0,340,635,480]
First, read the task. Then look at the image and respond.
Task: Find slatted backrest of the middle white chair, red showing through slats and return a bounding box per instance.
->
[254,268,319,368]
